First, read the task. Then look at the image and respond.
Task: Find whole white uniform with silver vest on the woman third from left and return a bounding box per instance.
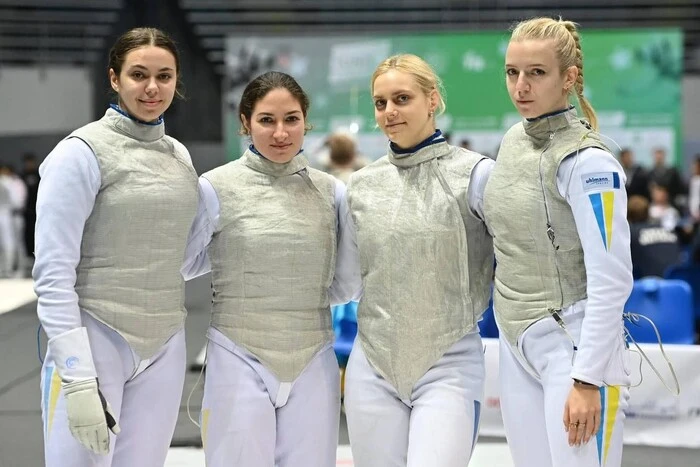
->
[345,130,493,467]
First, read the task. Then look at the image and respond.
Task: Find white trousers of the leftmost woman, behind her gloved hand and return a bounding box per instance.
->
[41,313,187,467]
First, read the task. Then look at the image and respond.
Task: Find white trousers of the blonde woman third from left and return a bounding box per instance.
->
[345,332,484,467]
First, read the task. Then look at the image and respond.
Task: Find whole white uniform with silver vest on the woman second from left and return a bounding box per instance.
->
[183,147,360,467]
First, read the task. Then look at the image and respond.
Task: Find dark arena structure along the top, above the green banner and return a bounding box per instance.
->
[0,0,700,74]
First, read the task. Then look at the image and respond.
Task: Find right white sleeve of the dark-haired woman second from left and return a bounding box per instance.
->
[328,180,362,305]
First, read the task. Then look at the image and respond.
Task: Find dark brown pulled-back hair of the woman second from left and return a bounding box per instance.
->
[238,71,311,135]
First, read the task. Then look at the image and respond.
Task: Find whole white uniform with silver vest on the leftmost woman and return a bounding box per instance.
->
[33,108,197,467]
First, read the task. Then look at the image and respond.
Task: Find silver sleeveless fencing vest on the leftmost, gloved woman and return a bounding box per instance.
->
[68,109,198,359]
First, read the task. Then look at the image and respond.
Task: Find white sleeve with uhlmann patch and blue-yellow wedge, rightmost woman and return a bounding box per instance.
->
[557,148,633,386]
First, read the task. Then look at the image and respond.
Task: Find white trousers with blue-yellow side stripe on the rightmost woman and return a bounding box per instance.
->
[499,311,629,467]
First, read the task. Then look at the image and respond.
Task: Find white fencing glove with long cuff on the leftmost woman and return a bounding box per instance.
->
[48,327,120,455]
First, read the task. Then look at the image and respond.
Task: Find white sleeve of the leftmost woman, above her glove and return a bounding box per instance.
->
[32,138,101,339]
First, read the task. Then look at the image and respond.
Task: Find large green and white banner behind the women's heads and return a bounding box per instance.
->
[224,29,683,164]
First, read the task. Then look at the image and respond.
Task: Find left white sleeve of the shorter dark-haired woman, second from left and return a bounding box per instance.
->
[180,177,220,281]
